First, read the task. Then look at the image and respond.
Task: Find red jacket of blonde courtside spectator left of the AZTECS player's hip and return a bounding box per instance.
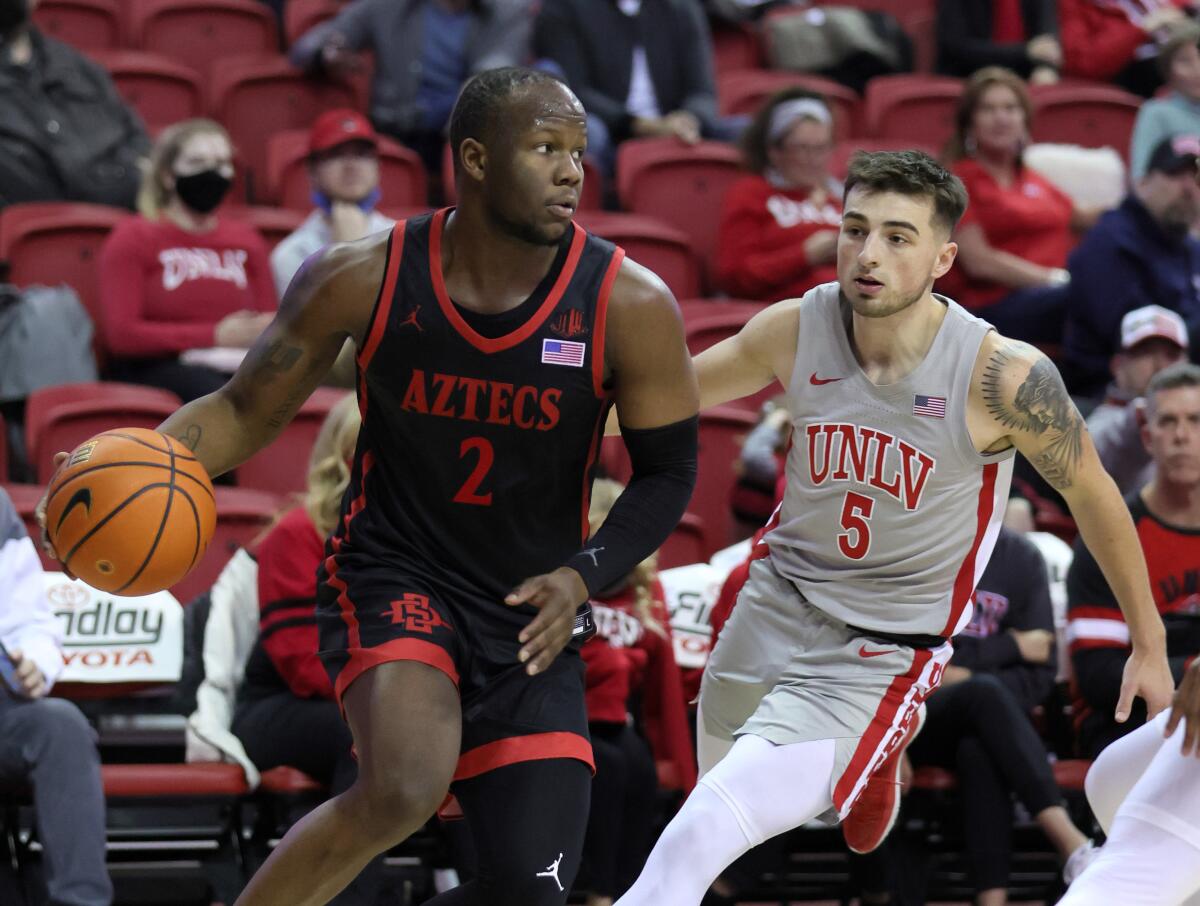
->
[249,506,334,698]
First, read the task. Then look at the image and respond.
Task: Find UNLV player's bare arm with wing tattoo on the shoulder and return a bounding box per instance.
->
[972,335,1175,722]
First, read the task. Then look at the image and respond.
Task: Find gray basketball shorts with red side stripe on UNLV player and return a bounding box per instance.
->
[700,557,953,820]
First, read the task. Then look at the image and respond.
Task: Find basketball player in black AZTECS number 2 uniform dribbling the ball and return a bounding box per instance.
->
[60,70,697,906]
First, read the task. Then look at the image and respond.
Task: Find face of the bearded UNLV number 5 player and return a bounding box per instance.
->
[838,186,958,318]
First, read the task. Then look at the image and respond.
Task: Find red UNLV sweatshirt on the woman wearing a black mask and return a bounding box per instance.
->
[100,217,277,359]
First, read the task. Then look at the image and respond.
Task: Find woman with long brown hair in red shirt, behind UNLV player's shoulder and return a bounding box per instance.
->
[938,66,1093,342]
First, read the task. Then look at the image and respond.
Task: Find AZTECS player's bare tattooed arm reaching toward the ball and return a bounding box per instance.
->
[158,233,388,475]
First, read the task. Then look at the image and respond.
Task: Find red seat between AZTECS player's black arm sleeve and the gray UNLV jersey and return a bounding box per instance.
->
[689,406,756,556]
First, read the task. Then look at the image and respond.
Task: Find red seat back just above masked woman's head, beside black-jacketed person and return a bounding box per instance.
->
[92,50,204,128]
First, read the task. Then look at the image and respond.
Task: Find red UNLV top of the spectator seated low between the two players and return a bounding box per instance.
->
[581,580,696,791]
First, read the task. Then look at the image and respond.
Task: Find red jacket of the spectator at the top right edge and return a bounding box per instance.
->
[1058,0,1187,80]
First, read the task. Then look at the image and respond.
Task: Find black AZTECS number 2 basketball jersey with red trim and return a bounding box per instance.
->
[325,210,624,608]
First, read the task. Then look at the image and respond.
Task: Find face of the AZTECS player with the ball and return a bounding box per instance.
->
[486,83,588,245]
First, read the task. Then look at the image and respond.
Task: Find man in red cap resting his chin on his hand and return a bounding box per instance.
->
[271,110,395,299]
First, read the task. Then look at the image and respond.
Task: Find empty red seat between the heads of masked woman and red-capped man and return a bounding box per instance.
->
[209,55,355,200]
